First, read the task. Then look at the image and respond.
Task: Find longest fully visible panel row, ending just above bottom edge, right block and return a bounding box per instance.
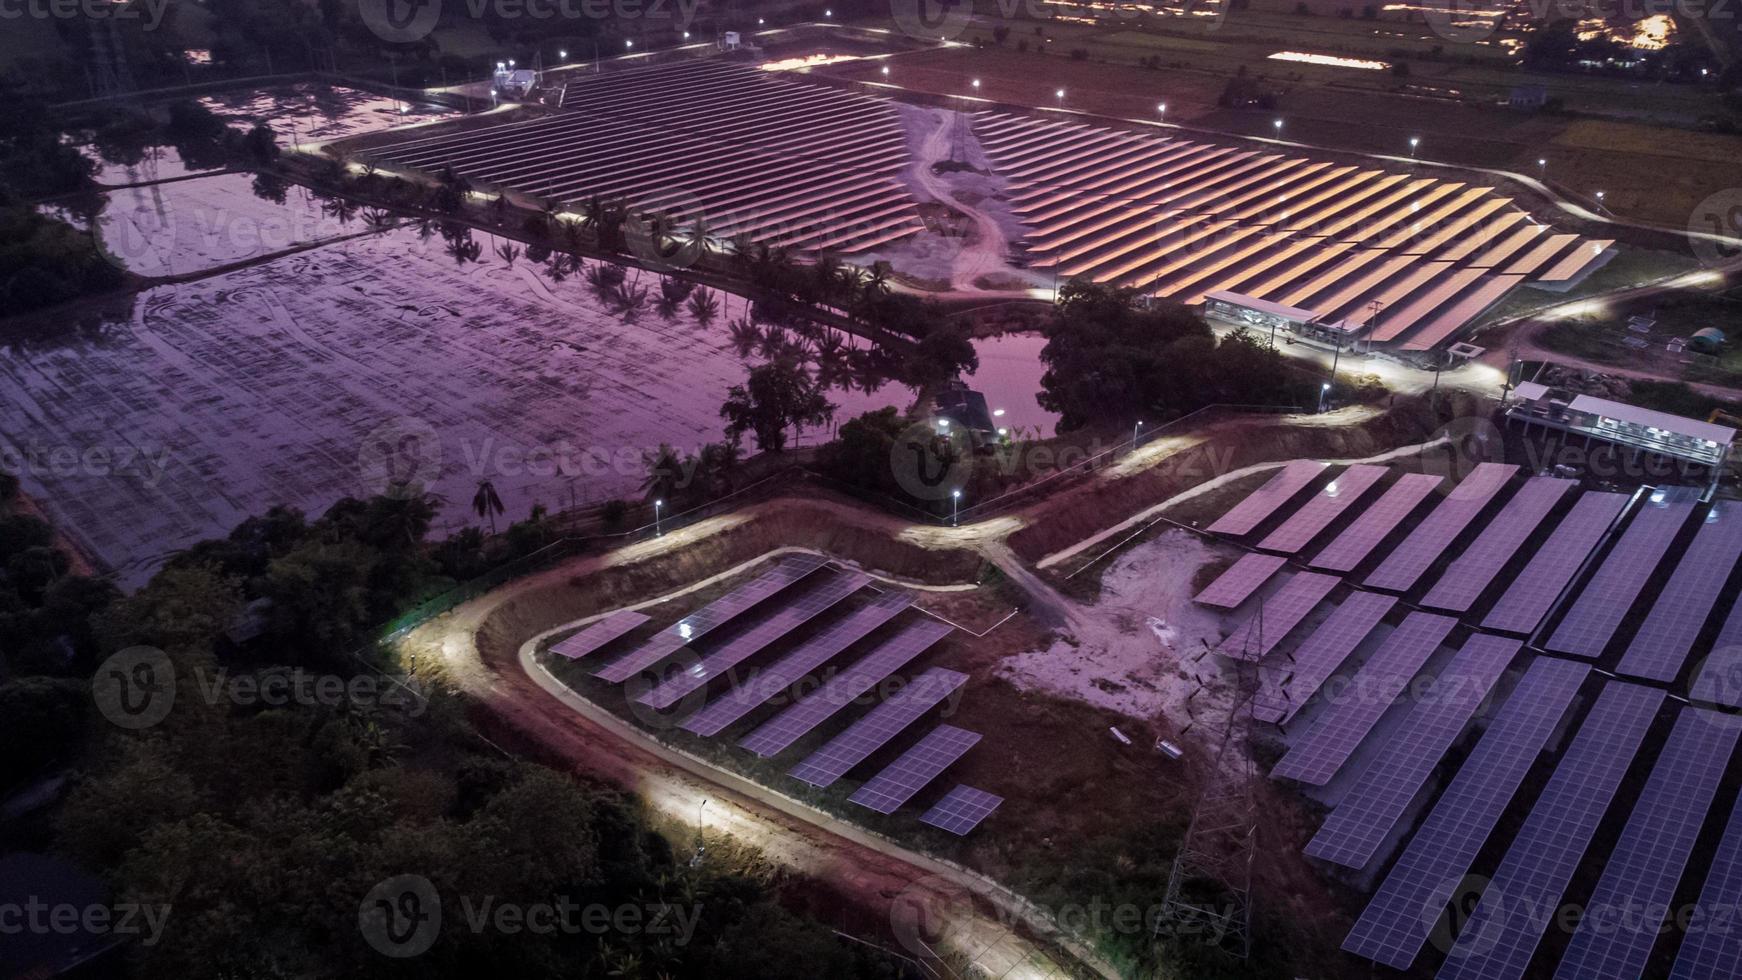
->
[1343,656,1590,970]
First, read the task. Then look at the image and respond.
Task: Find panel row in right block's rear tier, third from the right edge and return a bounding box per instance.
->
[1547,487,1698,656]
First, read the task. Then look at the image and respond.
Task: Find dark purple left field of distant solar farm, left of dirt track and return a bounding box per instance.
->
[373,61,923,254]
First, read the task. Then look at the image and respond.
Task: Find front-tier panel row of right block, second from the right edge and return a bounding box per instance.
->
[1554,708,1739,980]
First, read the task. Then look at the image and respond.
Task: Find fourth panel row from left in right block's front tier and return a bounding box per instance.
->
[1270,613,1458,787]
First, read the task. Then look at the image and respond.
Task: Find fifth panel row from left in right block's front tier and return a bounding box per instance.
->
[1307,635,1524,869]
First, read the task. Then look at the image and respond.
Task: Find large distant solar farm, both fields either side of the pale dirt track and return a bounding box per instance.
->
[353,53,1615,352]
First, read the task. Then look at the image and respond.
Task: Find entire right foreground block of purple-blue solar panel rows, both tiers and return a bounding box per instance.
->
[1195,461,1742,980]
